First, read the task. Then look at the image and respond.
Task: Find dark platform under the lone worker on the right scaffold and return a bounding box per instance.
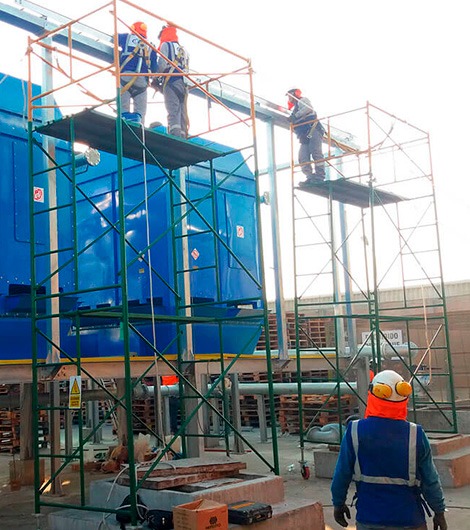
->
[296,179,406,208]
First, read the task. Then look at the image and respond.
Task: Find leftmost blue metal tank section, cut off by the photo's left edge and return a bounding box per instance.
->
[0,76,77,363]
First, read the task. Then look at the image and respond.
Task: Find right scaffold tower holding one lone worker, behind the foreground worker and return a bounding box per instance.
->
[291,103,457,463]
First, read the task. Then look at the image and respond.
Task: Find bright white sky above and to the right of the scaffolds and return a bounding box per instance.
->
[0,0,470,288]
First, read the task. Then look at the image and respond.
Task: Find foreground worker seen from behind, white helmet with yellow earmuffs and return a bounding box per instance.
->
[331,370,447,530]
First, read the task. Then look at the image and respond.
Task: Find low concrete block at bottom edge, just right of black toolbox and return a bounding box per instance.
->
[229,499,325,530]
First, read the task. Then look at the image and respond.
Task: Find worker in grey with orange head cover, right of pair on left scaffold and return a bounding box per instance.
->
[157,26,189,138]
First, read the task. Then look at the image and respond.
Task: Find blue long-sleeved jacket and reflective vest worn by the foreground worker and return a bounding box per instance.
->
[331,417,445,529]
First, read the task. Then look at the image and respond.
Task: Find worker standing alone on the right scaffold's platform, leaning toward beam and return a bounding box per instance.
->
[286,88,325,186]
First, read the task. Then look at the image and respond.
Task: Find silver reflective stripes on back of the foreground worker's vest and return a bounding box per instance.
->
[351,420,420,487]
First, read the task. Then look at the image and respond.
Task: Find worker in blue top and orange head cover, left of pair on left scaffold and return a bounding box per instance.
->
[118,22,157,124]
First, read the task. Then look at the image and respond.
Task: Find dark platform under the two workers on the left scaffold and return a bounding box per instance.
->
[36,109,224,170]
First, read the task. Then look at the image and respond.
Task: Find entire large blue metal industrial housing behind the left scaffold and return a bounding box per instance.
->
[0,72,262,362]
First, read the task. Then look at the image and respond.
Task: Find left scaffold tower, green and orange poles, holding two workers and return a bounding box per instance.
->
[28,0,279,524]
